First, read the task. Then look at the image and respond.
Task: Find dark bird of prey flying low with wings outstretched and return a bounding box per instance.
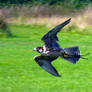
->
[33,18,81,77]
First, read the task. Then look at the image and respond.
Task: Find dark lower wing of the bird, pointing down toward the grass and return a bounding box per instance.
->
[34,56,60,77]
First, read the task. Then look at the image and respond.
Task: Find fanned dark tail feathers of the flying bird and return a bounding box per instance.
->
[62,46,81,64]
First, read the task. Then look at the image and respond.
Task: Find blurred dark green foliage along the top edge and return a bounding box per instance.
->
[0,0,92,9]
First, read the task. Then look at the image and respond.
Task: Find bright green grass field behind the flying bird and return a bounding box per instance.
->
[0,25,92,92]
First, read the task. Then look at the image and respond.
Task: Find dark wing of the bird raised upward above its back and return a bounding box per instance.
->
[41,18,71,47]
